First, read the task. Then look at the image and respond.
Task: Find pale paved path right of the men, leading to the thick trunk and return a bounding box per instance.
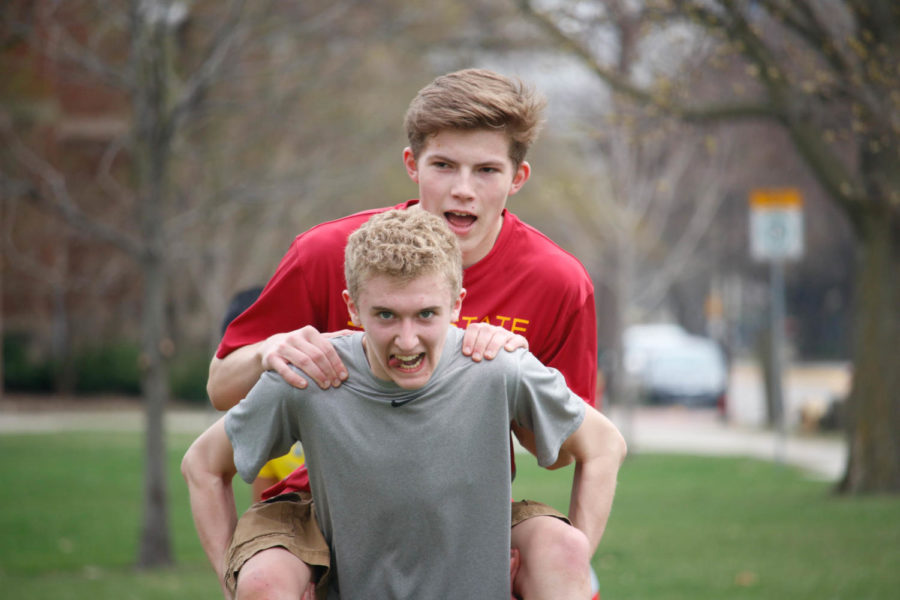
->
[607,406,847,481]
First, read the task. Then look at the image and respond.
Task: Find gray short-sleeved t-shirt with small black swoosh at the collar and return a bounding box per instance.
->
[225,327,585,600]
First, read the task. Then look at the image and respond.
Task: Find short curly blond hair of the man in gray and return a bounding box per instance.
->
[344,207,462,302]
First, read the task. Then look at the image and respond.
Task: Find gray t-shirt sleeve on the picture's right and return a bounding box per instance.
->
[495,350,585,467]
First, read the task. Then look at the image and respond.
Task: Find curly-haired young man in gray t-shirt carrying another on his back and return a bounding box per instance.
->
[182,208,624,600]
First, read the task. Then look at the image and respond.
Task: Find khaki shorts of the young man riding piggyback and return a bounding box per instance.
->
[225,492,571,597]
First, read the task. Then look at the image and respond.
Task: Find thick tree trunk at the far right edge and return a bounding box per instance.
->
[838,202,900,494]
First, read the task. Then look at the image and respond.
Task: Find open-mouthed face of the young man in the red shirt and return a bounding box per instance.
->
[403,129,531,267]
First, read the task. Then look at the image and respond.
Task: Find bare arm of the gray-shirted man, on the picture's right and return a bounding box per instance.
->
[551,406,627,554]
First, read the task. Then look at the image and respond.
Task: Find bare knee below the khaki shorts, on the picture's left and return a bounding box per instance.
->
[236,548,312,600]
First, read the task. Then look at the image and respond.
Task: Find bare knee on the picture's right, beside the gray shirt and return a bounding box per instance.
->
[512,516,591,600]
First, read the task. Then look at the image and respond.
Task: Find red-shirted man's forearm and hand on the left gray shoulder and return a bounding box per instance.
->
[206,325,347,410]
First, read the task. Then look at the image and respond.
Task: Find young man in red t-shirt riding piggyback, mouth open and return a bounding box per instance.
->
[208,70,615,599]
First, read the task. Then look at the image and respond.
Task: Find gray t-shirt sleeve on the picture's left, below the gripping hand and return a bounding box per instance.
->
[225,371,301,483]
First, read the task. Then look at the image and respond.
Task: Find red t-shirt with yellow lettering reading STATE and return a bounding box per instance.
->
[216,200,597,497]
